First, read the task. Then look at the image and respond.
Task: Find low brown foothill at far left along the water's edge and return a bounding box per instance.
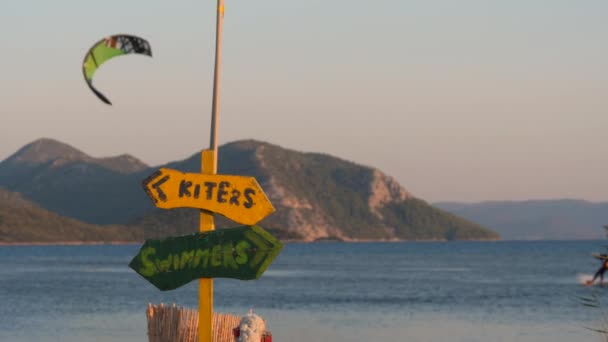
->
[0,188,143,243]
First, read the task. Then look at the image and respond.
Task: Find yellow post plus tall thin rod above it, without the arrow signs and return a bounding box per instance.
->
[198,0,224,342]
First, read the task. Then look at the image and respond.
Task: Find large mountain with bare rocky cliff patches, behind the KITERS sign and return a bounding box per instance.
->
[135,140,498,241]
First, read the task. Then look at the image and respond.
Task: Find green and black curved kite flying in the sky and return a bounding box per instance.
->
[82,34,152,105]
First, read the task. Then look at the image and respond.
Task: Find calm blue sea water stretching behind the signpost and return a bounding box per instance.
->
[0,241,608,342]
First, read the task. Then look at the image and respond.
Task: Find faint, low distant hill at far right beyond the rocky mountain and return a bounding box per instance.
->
[435,199,608,240]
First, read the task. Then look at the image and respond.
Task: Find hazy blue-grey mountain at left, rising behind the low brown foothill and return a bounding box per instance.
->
[0,139,149,224]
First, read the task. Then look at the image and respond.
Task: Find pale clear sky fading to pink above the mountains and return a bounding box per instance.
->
[0,0,608,202]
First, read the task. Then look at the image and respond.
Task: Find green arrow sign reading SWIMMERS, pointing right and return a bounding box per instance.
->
[129,226,283,291]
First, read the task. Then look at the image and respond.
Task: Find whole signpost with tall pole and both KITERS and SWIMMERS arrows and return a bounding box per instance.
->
[129,0,282,342]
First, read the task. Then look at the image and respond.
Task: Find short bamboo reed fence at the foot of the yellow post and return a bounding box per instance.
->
[146,303,241,342]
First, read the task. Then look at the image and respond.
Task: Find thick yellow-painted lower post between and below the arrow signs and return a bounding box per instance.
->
[198,150,217,342]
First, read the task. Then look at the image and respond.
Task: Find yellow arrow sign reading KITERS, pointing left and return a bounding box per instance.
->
[142,168,274,225]
